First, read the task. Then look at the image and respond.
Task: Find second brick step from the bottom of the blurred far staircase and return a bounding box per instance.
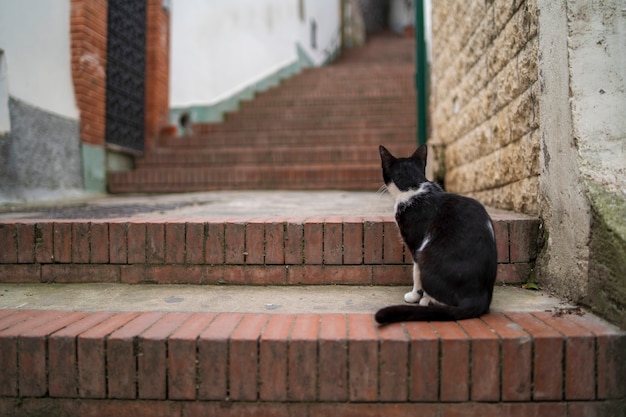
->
[136,145,414,169]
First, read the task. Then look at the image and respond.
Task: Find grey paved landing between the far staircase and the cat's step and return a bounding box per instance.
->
[0,191,525,220]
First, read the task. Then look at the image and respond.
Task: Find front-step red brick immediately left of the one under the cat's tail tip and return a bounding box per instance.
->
[318,314,348,401]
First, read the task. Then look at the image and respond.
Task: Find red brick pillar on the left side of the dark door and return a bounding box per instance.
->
[70,0,107,146]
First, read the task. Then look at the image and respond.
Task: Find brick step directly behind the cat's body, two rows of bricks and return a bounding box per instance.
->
[0,211,539,285]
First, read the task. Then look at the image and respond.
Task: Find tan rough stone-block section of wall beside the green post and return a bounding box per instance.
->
[429,0,540,214]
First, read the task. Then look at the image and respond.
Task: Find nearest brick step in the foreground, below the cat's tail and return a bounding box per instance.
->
[0,309,626,417]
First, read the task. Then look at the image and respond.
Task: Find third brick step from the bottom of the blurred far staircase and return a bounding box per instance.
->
[159,124,417,149]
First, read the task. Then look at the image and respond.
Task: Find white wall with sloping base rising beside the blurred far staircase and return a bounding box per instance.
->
[170,0,340,121]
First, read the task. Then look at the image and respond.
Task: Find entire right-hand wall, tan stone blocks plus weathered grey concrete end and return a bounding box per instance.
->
[429,0,626,326]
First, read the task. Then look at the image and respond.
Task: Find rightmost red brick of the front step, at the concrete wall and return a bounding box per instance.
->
[566,314,626,399]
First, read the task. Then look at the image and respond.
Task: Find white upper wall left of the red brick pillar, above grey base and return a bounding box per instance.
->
[0,0,78,119]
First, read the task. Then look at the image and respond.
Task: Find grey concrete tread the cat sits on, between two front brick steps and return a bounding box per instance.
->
[0,284,570,314]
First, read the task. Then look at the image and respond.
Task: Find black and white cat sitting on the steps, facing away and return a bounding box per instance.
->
[376,145,497,324]
